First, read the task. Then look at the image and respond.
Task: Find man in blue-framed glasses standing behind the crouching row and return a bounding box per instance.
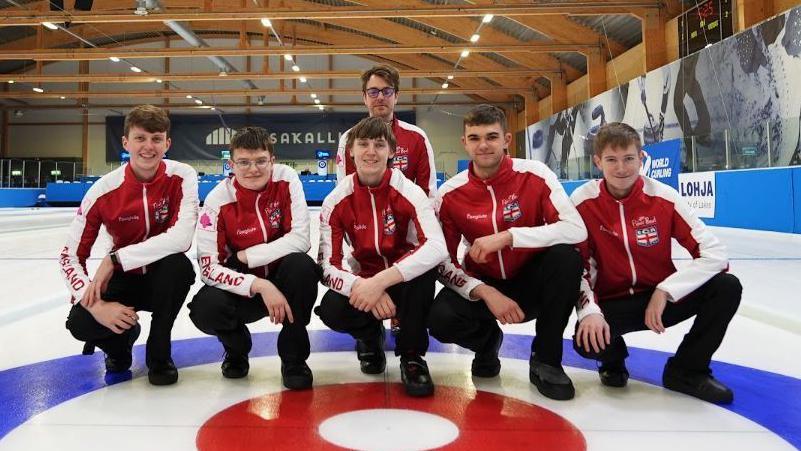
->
[337,64,437,198]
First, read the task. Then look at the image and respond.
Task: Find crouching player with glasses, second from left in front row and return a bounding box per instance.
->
[189,127,320,390]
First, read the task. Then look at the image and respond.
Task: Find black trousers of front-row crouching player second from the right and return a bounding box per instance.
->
[428,244,582,366]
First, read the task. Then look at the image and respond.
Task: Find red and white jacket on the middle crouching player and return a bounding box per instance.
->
[319,169,447,296]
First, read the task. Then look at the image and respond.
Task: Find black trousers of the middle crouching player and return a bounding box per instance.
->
[315,269,437,356]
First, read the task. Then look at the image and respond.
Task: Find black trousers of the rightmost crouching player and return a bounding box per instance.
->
[573,273,743,372]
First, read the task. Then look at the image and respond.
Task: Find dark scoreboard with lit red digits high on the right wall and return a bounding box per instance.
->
[679,0,734,57]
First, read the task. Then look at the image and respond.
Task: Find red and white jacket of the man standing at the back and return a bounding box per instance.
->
[337,117,437,198]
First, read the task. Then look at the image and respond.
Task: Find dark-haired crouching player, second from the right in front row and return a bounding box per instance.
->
[429,105,587,400]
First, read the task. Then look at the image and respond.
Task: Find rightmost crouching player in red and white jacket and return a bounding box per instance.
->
[571,123,742,403]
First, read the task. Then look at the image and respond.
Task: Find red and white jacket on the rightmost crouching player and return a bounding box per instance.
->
[571,176,729,321]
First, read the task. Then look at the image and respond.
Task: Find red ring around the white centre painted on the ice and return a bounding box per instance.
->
[197,383,587,451]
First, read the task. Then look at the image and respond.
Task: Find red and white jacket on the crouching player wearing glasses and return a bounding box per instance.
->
[197,164,311,297]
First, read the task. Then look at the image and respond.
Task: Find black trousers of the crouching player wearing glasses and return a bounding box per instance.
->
[188,252,320,362]
